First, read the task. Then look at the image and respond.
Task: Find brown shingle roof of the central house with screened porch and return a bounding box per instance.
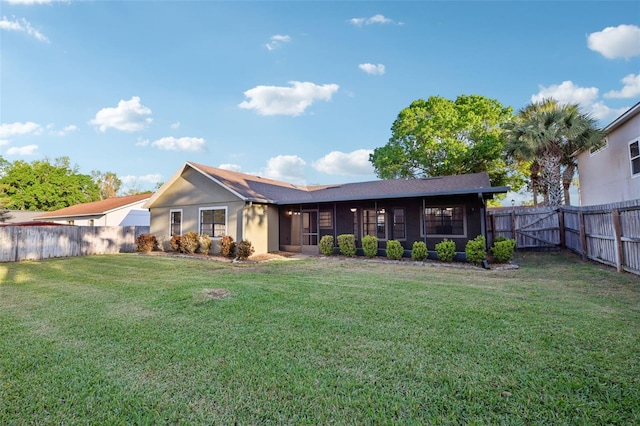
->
[145,162,509,207]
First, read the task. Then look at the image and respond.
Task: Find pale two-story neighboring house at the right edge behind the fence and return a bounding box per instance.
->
[578,102,640,206]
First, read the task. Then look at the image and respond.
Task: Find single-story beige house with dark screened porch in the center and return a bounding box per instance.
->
[145,162,509,254]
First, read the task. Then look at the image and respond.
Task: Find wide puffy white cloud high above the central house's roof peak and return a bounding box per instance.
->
[238,81,340,116]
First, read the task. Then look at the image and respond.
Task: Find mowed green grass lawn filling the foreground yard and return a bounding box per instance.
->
[0,253,640,425]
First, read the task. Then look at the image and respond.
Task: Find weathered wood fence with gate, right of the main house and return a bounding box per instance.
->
[487,200,640,275]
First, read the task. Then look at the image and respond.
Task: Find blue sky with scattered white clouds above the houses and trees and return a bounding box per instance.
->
[0,0,640,201]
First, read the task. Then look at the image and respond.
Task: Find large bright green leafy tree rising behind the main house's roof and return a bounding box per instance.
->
[369,95,524,190]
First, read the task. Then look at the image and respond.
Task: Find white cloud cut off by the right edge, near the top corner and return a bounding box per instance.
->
[587,25,640,59]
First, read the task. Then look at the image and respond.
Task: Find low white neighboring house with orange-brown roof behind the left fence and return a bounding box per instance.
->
[33,194,152,226]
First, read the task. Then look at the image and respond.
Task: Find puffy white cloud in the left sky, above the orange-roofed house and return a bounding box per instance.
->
[89,96,153,132]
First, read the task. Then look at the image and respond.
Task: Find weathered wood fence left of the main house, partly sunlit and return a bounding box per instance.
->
[0,226,149,262]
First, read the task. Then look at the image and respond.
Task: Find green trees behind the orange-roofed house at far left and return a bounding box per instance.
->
[0,157,100,211]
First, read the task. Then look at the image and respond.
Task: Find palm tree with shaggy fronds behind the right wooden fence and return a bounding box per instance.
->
[506,99,602,207]
